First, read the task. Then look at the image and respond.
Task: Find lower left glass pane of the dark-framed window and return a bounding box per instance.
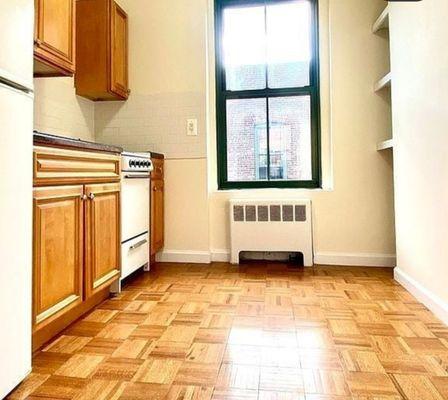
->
[227,98,268,182]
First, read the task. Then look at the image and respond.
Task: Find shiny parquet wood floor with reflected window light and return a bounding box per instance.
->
[9,263,448,400]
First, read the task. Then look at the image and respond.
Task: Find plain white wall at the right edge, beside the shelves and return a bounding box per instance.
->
[390,0,448,321]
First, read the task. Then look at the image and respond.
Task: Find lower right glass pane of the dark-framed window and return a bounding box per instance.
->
[269,96,312,181]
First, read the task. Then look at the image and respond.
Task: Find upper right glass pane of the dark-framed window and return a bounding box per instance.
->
[266,0,311,88]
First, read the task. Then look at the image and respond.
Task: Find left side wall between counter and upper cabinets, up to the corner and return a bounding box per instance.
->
[34,78,95,140]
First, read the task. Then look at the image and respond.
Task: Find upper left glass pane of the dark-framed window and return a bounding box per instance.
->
[223,6,266,91]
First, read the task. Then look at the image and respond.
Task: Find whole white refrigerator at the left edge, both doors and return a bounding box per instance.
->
[0,0,34,399]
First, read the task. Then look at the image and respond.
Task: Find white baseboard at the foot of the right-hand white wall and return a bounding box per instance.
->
[394,267,448,325]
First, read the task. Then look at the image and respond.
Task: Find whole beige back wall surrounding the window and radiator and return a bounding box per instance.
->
[31,0,395,264]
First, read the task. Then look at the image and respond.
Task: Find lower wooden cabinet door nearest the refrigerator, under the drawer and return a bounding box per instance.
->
[33,186,84,328]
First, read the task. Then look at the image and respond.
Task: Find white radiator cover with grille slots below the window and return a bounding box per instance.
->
[230,200,313,266]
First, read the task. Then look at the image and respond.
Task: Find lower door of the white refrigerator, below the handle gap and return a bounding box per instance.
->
[0,83,33,399]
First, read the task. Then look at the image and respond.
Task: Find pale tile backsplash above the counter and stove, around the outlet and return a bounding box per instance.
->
[34,78,206,158]
